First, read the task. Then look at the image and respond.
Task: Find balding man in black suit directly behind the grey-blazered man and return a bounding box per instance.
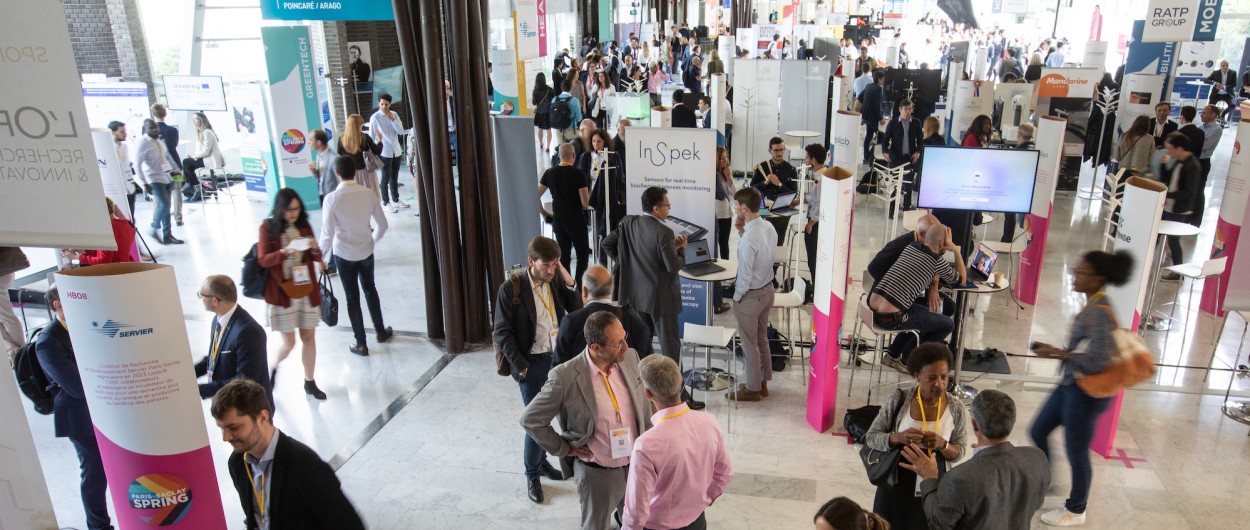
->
[555,265,651,365]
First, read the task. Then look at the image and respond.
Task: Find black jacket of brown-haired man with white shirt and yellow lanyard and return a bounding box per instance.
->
[491,270,581,383]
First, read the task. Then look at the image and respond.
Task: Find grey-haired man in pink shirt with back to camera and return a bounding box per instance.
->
[621,355,734,530]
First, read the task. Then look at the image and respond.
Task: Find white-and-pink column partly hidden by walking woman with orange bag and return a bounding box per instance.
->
[1090,176,1168,458]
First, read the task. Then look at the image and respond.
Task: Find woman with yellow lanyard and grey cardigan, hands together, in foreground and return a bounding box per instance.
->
[864,343,968,530]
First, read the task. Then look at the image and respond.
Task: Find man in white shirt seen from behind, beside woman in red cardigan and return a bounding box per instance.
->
[321,156,395,356]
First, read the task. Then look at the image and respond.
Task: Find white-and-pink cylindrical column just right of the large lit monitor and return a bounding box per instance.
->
[1006,116,1068,305]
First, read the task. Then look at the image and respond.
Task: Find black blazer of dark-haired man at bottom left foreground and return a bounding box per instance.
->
[226,431,365,530]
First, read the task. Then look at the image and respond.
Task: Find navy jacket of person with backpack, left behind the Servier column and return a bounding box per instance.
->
[35,320,95,438]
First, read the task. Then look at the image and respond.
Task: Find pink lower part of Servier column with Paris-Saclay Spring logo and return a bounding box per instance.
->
[95,429,225,529]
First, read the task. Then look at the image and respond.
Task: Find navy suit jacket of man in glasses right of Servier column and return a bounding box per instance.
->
[195,306,274,405]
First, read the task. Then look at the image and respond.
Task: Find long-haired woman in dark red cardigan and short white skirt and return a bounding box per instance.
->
[256,188,327,400]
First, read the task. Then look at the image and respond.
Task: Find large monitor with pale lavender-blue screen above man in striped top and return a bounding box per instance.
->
[916,146,1039,214]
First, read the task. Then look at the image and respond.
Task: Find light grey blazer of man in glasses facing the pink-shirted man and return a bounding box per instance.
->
[521,348,651,456]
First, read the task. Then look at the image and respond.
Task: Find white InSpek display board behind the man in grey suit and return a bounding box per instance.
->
[625,128,716,329]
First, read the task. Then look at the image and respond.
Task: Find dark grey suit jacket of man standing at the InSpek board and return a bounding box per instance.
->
[604,215,686,316]
